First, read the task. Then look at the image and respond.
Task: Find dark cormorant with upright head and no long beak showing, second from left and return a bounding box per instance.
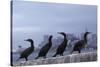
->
[35,35,53,59]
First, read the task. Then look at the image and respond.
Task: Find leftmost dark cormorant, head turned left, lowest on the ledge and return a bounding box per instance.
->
[18,39,34,61]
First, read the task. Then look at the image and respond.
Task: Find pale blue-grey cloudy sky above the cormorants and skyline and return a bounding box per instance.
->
[13,1,97,48]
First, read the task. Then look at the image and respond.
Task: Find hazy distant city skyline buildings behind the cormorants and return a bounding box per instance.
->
[39,33,97,49]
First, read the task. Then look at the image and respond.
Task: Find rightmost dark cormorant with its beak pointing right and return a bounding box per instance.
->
[71,32,90,53]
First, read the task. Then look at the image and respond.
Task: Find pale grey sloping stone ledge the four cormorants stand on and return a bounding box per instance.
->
[13,52,97,66]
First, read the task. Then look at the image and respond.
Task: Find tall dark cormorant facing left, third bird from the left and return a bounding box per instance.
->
[53,32,68,57]
